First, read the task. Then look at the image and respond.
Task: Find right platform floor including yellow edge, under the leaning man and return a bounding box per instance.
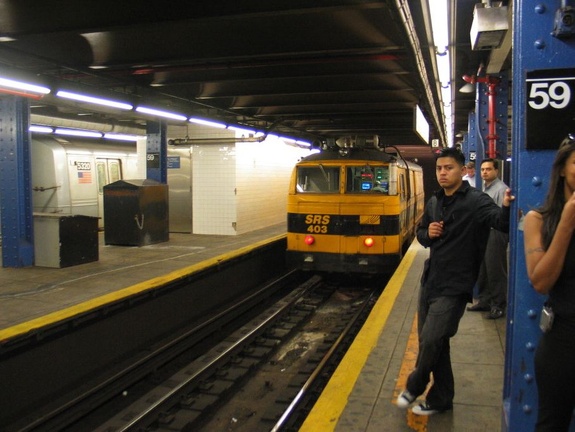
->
[300,241,506,432]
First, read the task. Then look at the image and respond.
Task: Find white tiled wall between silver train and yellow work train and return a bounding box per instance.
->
[183,121,309,235]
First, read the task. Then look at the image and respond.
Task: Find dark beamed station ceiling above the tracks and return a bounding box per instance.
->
[0,0,509,145]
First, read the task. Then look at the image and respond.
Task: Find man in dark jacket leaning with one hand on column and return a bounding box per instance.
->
[396,148,514,415]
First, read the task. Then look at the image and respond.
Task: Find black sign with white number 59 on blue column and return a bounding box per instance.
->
[526,69,575,150]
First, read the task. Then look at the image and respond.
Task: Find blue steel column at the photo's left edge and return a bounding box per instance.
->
[0,96,34,267]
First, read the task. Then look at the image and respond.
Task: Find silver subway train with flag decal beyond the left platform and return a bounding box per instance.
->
[31,134,196,232]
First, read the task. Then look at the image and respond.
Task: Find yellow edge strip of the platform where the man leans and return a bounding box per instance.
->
[299,242,419,432]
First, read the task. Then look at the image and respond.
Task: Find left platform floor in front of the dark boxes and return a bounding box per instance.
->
[0,223,286,336]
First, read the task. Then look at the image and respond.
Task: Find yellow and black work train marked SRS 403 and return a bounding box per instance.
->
[286,148,424,274]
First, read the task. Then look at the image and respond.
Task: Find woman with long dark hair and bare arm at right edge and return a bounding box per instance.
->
[524,135,575,432]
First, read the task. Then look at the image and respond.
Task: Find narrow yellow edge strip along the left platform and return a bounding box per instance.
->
[0,234,286,343]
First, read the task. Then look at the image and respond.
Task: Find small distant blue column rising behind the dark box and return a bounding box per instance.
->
[146,121,168,183]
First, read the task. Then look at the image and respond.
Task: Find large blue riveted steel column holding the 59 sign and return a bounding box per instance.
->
[503,0,575,432]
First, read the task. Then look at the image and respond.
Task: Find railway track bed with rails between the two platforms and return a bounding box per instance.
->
[13,273,383,432]
